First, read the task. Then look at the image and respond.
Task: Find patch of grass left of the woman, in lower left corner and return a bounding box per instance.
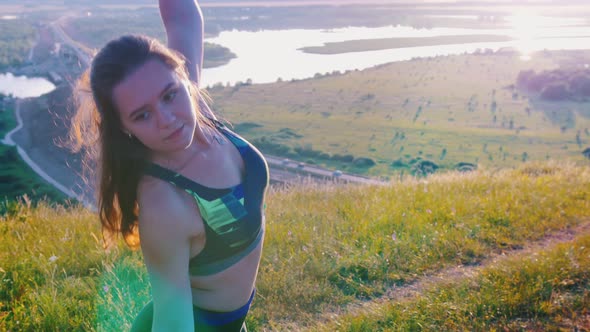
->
[0,203,147,331]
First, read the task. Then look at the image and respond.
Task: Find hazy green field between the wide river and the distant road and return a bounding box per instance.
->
[209,52,590,176]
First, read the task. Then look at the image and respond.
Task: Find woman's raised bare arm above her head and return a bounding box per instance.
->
[159,0,216,119]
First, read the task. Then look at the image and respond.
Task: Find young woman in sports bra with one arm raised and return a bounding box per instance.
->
[72,0,269,331]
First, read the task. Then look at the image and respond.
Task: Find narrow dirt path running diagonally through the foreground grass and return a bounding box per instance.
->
[309,218,590,330]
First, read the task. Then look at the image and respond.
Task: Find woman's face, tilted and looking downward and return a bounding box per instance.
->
[113,59,197,155]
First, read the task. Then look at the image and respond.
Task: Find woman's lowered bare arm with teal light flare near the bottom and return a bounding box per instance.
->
[139,183,194,331]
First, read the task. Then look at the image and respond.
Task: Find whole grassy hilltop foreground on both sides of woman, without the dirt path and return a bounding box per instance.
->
[0,163,590,331]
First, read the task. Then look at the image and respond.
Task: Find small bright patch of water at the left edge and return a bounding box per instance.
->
[0,73,55,98]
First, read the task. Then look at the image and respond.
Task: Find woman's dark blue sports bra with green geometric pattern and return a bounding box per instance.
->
[145,120,269,276]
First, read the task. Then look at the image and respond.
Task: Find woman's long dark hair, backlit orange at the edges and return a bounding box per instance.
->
[70,35,211,249]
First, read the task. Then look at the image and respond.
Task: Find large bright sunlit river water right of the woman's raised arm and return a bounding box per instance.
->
[203,20,590,85]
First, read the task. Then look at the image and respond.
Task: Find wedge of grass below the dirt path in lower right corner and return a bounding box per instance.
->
[312,234,590,331]
